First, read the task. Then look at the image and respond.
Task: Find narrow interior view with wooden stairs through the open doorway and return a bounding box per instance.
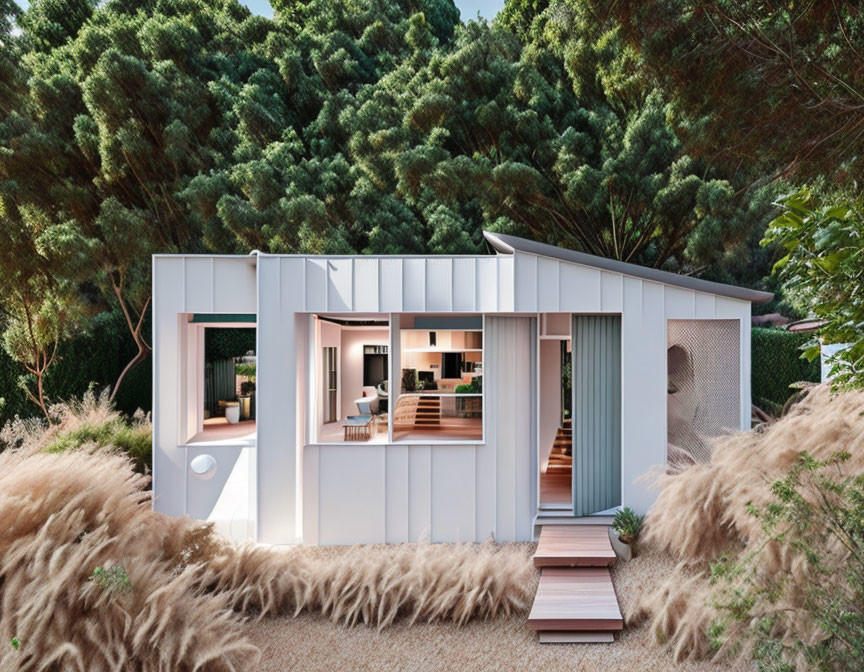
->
[537,314,573,511]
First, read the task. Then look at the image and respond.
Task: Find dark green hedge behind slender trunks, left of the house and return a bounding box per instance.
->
[0,312,153,425]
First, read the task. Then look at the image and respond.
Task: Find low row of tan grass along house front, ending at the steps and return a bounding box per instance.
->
[209,541,536,630]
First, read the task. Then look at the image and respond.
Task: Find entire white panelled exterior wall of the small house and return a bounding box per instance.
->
[153,252,750,543]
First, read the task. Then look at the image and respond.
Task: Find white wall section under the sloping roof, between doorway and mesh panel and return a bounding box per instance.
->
[513,252,750,513]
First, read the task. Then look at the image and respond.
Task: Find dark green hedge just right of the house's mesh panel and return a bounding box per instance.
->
[751,328,820,411]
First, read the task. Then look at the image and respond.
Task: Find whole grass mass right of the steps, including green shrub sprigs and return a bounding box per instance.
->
[625,386,864,672]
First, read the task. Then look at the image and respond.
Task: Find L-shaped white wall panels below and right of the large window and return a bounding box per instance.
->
[303,317,536,545]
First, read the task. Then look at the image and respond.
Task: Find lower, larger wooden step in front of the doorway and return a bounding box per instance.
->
[528,568,624,634]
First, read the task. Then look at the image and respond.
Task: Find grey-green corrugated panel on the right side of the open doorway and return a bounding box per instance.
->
[572,315,621,516]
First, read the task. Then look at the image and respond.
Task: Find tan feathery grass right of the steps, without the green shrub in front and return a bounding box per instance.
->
[625,386,864,669]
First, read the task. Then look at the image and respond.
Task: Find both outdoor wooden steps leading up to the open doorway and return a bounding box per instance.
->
[528,525,624,644]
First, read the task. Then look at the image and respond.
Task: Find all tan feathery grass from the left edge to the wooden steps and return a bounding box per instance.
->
[0,404,536,672]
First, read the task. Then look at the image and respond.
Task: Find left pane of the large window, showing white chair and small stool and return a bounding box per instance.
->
[314,314,390,443]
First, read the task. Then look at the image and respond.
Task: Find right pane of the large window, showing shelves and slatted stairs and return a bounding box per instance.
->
[393,315,483,442]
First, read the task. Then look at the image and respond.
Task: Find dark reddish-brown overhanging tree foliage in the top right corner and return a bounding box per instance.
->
[593,0,864,182]
